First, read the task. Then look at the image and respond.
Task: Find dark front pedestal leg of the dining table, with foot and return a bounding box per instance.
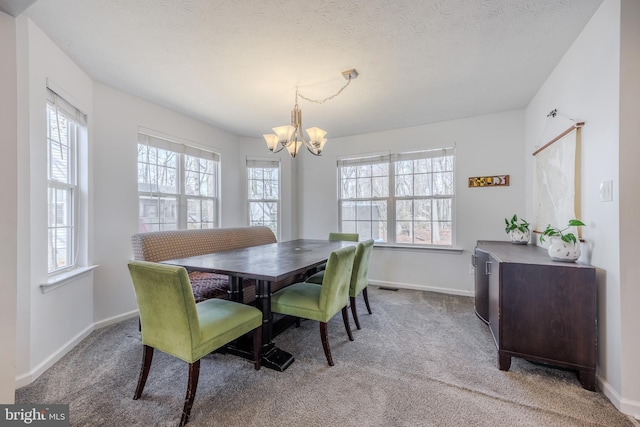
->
[256,280,294,371]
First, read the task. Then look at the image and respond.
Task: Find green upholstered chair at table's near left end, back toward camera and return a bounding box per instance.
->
[129,261,262,426]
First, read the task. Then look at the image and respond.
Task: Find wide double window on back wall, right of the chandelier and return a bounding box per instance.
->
[338,148,455,247]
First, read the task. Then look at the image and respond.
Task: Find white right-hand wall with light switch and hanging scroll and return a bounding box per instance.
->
[525,0,640,413]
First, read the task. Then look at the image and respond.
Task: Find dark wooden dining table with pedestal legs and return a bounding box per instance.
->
[162,239,357,371]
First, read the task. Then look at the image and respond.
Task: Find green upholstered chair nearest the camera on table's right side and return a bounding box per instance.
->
[271,246,356,366]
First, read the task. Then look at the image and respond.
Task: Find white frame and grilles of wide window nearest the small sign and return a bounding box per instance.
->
[337,147,456,249]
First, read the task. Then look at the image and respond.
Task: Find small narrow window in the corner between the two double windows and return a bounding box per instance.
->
[247,159,280,236]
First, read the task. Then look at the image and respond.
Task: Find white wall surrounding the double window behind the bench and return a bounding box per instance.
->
[93,83,246,325]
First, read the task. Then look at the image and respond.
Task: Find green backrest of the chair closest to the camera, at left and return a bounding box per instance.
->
[128,261,200,361]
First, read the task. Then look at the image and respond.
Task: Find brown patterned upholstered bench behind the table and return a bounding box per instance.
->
[131,227,278,304]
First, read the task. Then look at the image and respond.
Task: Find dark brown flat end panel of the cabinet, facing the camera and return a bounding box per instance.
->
[500,263,596,367]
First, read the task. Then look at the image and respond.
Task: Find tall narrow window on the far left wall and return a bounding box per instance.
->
[47,89,87,274]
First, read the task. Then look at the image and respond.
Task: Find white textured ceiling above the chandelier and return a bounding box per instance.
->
[20,0,602,138]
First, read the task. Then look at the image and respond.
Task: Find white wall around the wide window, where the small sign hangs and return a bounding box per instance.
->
[258,111,525,295]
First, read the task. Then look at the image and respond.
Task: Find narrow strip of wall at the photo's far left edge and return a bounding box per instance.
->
[0,12,18,404]
